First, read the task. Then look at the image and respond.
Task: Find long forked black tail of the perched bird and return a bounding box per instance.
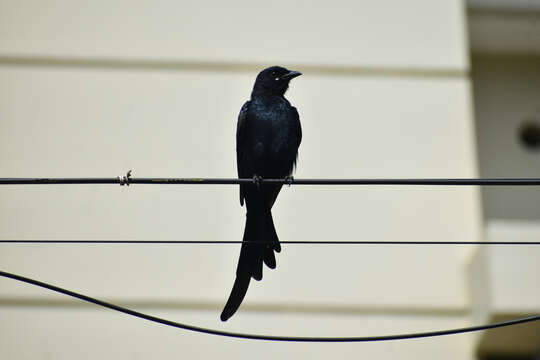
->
[221,209,281,321]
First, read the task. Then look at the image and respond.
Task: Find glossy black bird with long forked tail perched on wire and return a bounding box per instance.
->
[221,66,302,321]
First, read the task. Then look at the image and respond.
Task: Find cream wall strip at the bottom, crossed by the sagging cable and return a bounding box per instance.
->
[0,308,474,360]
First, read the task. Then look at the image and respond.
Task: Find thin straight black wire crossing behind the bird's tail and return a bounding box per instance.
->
[0,240,540,245]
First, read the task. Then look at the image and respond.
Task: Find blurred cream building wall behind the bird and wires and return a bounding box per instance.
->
[0,0,540,359]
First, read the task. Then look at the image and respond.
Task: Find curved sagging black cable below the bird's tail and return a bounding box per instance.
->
[0,271,540,342]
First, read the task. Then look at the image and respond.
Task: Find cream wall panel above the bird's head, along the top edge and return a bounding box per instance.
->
[0,0,467,69]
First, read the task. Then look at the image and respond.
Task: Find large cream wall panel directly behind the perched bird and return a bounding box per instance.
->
[0,68,479,307]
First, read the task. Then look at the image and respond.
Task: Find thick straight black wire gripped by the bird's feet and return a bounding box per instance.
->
[0,176,540,186]
